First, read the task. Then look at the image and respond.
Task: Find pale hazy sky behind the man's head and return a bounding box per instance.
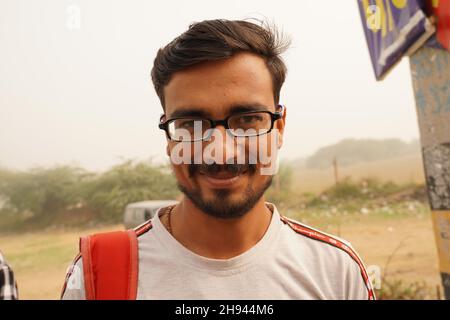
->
[0,0,419,170]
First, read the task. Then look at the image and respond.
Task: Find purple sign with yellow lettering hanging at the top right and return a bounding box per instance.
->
[358,0,435,80]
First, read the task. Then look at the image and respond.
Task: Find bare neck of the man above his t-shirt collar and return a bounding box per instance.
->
[171,197,272,259]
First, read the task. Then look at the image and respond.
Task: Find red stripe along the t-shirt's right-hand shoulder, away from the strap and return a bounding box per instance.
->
[280,215,375,300]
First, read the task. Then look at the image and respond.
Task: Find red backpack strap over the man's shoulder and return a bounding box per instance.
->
[80,230,138,300]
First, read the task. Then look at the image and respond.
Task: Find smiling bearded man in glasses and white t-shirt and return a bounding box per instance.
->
[63,20,374,299]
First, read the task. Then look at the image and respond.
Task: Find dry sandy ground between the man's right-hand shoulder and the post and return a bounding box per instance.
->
[341,218,440,287]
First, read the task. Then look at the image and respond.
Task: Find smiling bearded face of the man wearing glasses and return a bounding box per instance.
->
[164,53,285,218]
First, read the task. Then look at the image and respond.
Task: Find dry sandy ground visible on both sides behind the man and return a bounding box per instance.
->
[0,212,440,299]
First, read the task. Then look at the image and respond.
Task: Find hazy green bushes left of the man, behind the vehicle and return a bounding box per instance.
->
[0,161,179,229]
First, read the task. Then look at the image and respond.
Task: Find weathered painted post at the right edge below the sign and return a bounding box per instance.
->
[410,47,450,300]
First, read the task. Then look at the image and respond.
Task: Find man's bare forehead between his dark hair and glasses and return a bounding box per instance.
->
[164,53,274,117]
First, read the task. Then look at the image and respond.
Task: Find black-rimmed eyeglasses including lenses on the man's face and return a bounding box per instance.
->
[158,105,284,142]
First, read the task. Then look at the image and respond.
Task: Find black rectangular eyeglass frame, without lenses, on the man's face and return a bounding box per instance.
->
[158,104,284,142]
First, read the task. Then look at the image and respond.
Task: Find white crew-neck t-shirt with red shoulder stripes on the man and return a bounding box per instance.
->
[62,203,373,300]
